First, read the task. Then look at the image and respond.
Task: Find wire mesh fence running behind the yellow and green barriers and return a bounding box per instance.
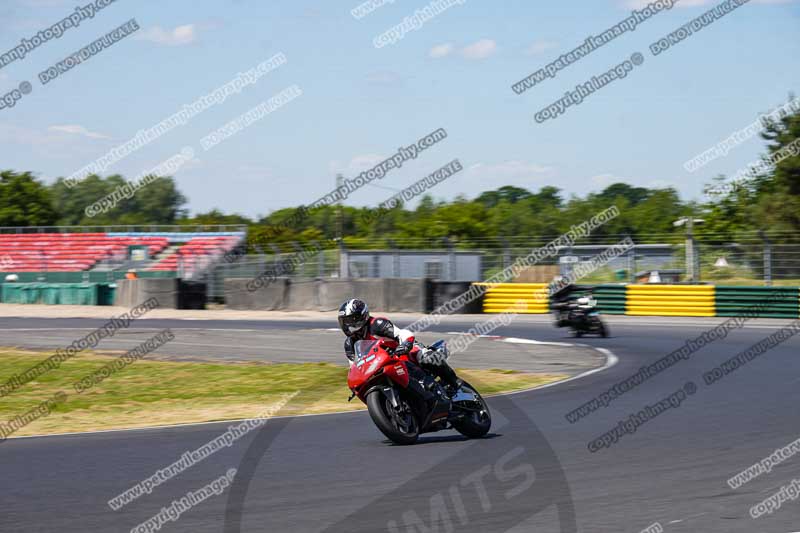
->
[207,233,800,302]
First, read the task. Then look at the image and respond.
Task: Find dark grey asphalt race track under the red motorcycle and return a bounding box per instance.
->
[0,317,800,533]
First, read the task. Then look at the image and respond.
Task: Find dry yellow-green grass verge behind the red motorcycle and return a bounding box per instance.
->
[0,350,567,438]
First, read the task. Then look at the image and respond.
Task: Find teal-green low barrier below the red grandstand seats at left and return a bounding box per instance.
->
[0,283,114,305]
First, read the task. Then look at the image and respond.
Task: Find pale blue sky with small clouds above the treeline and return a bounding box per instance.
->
[0,0,800,216]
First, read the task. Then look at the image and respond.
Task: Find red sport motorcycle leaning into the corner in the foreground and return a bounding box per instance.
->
[347,340,492,444]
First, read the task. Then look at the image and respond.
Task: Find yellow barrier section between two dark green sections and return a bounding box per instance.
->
[625,285,716,316]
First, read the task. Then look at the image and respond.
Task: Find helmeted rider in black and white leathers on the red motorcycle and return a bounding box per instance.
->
[339,298,462,396]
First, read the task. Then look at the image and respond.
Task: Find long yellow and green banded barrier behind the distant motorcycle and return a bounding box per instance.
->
[476,283,800,318]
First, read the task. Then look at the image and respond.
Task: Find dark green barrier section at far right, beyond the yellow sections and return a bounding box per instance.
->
[716,285,800,318]
